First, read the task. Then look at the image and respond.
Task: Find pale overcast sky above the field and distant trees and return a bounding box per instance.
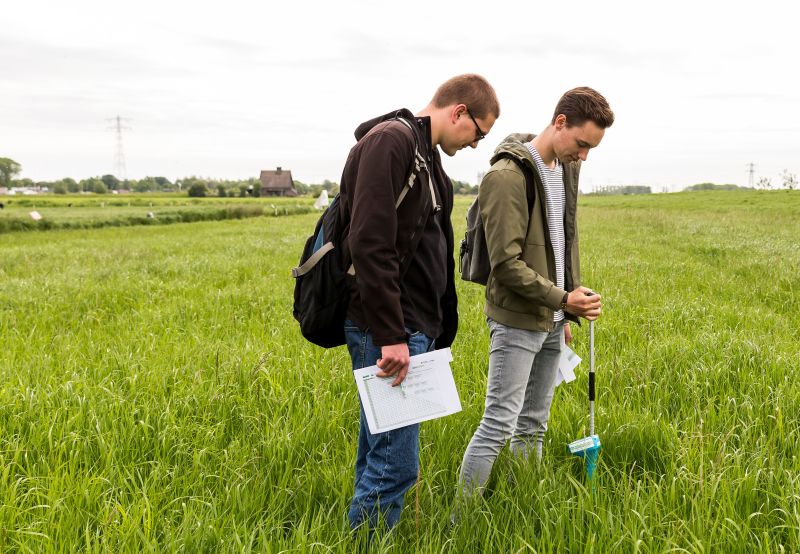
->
[0,0,800,192]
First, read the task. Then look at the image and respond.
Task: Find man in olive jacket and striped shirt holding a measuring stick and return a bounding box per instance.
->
[460,87,614,496]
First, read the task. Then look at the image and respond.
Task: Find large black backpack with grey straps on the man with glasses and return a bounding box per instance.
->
[292,117,438,348]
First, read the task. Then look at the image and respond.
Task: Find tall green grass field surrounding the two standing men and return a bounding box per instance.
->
[0,191,800,553]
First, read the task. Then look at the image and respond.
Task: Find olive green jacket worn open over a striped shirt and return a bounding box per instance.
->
[478,134,580,332]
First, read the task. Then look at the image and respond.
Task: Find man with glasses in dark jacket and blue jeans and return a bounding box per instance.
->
[339,74,500,529]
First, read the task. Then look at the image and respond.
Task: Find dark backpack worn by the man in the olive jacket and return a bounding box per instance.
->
[458,153,536,286]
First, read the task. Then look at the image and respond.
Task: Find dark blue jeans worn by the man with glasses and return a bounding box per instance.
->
[344,321,434,529]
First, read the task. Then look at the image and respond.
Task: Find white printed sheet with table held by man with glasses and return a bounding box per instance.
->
[353,348,461,434]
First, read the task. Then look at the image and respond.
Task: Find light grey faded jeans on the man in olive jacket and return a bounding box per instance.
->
[459,318,564,496]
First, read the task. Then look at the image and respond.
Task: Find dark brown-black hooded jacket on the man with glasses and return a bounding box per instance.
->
[339,109,458,348]
